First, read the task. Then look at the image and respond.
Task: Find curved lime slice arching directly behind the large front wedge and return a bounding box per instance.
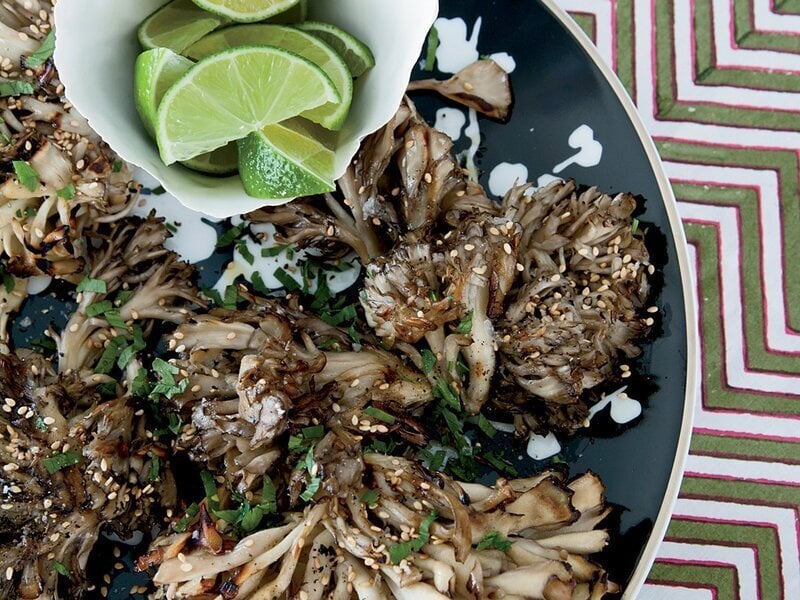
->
[185,25,353,130]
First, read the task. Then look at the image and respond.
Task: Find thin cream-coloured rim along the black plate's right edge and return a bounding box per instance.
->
[539,0,699,600]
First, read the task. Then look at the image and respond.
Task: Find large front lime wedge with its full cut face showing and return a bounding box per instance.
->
[156,46,339,165]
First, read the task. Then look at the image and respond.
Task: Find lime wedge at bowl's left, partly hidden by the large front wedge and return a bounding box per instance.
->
[133,48,194,137]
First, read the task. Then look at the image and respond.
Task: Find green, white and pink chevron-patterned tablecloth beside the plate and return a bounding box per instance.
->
[558,0,800,600]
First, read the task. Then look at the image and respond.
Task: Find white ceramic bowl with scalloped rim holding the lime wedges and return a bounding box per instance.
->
[55,0,439,218]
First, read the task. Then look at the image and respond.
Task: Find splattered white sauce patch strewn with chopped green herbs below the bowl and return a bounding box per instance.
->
[214,217,361,294]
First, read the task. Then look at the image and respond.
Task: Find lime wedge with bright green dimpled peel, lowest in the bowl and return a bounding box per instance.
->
[238,120,335,199]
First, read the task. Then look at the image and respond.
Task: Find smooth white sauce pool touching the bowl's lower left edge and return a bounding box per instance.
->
[131,169,220,264]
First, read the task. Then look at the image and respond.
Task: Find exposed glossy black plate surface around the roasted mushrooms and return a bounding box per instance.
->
[13,0,693,598]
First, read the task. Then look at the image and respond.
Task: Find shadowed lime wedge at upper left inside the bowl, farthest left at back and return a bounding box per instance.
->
[138,0,228,52]
